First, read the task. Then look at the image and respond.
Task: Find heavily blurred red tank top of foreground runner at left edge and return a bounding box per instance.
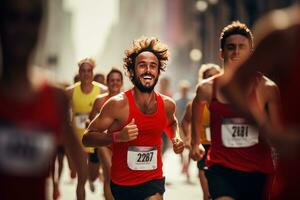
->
[0,86,61,200]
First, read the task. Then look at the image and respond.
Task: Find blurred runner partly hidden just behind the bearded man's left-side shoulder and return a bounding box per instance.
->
[89,68,123,200]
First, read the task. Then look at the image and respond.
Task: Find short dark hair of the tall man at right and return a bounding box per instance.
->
[220,21,253,50]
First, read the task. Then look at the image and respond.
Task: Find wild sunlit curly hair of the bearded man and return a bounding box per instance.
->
[123,36,169,72]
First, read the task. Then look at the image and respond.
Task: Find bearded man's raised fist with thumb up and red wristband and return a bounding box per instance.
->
[116,119,139,142]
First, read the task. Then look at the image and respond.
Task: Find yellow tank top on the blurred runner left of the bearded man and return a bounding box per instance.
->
[71,81,101,153]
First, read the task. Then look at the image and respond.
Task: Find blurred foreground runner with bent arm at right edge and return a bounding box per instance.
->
[225,3,300,200]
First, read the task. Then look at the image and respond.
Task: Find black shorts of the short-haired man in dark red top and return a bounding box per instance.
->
[205,164,267,200]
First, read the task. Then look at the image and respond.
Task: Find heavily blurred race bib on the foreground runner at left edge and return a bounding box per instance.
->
[0,127,55,176]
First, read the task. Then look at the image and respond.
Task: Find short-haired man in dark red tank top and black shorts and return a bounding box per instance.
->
[191,22,273,199]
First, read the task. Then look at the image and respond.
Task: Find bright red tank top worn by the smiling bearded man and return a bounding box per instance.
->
[111,90,167,186]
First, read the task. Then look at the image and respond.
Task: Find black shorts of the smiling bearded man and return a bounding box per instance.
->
[110,178,165,200]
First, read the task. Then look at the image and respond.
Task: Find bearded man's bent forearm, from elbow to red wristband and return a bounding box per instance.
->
[82,131,113,147]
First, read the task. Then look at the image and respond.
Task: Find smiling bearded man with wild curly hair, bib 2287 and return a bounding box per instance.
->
[83,37,183,200]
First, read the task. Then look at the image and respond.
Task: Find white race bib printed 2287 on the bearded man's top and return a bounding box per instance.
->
[127,146,157,170]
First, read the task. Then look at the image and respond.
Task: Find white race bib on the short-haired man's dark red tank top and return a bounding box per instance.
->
[221,118,258,148]
